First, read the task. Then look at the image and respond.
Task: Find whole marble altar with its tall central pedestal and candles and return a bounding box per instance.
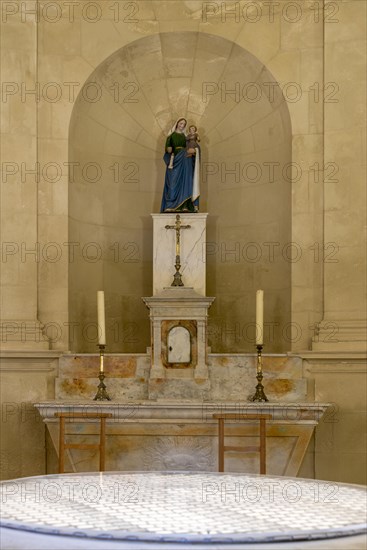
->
[35,216,328,477]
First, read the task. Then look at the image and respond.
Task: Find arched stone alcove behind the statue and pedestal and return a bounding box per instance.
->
[69,32,294,352]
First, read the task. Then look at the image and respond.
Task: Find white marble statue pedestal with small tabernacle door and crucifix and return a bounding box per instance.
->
[143,212,214,399]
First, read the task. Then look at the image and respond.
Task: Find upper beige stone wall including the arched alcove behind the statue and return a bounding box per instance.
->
[1,0,366,352]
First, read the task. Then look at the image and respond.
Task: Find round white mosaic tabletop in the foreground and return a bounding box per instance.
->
[0,472,367,544]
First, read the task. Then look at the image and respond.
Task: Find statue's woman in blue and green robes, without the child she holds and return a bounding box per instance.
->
[161,118,200,212]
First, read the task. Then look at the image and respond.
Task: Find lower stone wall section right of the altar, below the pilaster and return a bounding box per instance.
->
[303,352,367,484]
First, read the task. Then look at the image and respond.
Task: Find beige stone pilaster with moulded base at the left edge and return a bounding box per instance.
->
[0,0,49,350]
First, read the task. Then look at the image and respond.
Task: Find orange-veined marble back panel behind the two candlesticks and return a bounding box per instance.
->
[56,356,308,403]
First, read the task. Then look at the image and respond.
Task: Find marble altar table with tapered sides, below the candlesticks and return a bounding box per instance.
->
[35,401,328,476]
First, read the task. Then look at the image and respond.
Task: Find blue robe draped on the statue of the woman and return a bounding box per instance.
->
[161,134,199,212]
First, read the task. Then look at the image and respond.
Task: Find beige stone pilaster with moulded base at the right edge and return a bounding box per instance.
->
[313,0,367,351]
